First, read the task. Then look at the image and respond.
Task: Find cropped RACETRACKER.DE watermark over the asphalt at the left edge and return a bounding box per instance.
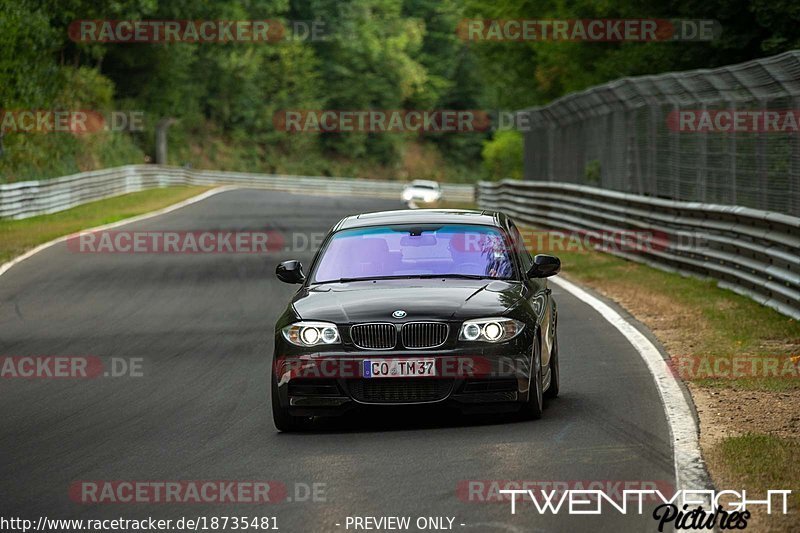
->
[0,355,144,380]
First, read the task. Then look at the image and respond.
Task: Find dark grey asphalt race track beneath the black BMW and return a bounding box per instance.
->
[0,190,674,532]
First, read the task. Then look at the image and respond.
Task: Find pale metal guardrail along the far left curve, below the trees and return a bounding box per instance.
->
[0,165,475,219]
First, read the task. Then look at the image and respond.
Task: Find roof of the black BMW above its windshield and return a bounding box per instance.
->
[333,209,505,231]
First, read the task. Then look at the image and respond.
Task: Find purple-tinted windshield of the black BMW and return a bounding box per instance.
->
[312,225,514,283]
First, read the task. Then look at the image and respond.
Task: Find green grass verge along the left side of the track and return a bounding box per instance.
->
[0,186,209,263]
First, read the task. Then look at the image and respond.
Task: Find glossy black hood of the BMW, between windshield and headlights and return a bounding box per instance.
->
[292,279,522,324]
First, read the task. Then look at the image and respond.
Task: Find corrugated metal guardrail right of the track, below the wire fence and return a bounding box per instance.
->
[477,180,800,319]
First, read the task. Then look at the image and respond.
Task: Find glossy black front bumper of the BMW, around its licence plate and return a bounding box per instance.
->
[273,342,531,416]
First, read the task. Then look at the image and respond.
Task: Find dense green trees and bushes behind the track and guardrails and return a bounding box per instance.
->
[0,0,800,181]
